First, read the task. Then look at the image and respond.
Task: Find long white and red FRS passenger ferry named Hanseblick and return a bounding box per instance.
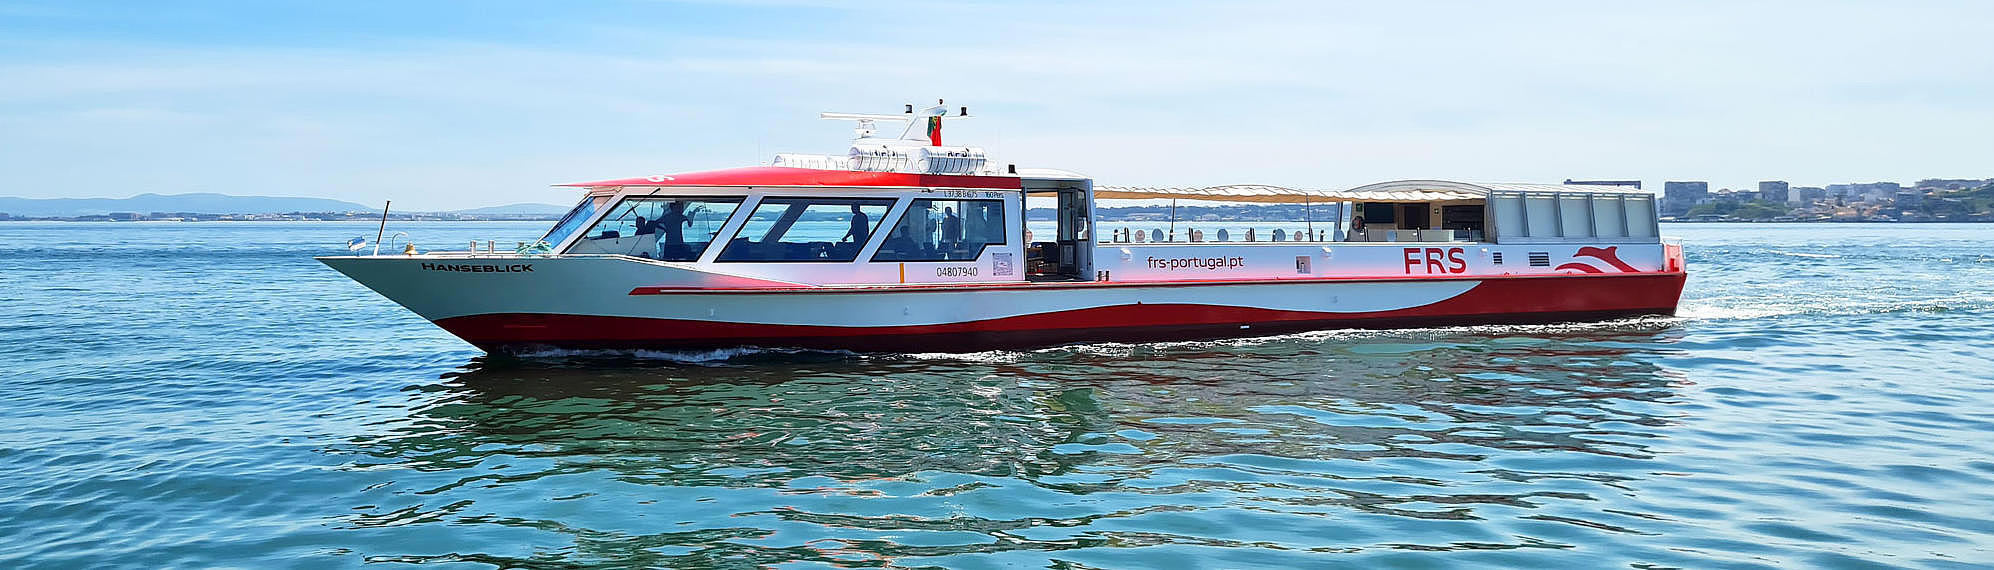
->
[319,106,1687,351]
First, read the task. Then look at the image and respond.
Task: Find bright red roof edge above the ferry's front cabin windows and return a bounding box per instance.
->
[558,165,1025,189]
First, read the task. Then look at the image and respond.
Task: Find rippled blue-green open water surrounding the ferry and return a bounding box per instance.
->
[0,223,1994,568]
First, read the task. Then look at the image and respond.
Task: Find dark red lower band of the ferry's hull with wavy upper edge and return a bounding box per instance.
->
[437,273,1685,351]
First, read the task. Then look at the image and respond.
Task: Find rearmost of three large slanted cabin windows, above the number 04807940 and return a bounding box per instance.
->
[873,197,1005,261]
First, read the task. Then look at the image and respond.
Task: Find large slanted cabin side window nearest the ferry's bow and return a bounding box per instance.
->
[568,195,742,261]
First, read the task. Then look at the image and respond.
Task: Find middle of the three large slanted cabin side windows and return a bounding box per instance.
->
[718,197,893,261]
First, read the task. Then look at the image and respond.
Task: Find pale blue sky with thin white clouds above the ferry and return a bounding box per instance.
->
[0,0,1994,209]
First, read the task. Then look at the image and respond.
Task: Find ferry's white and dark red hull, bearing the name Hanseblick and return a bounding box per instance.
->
[325,257,1685,351]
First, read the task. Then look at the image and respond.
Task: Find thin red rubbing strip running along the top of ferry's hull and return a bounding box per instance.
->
[630,267,1685,295]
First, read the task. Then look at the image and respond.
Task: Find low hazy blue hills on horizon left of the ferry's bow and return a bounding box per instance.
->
[0,193,381,217]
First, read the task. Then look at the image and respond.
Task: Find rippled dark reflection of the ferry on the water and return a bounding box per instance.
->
[343,321,1685,566]
